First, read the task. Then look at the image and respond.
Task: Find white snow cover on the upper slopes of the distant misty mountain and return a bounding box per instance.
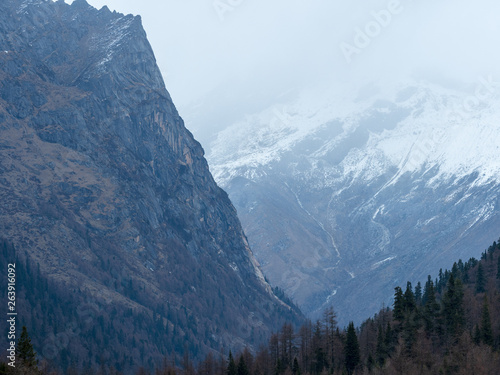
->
[208,78,500,186]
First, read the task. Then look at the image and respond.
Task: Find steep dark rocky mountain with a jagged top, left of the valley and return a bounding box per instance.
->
[0,0,302,372]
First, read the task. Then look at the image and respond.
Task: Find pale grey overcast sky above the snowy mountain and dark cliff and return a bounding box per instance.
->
[67,0,500,147]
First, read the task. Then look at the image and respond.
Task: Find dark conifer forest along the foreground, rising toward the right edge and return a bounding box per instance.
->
[0,240,500,375]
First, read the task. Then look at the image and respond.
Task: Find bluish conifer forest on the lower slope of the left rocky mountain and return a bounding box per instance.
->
[0,237,298,374]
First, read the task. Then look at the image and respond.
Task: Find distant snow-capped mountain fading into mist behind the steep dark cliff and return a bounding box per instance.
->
[208,77,500,324]
